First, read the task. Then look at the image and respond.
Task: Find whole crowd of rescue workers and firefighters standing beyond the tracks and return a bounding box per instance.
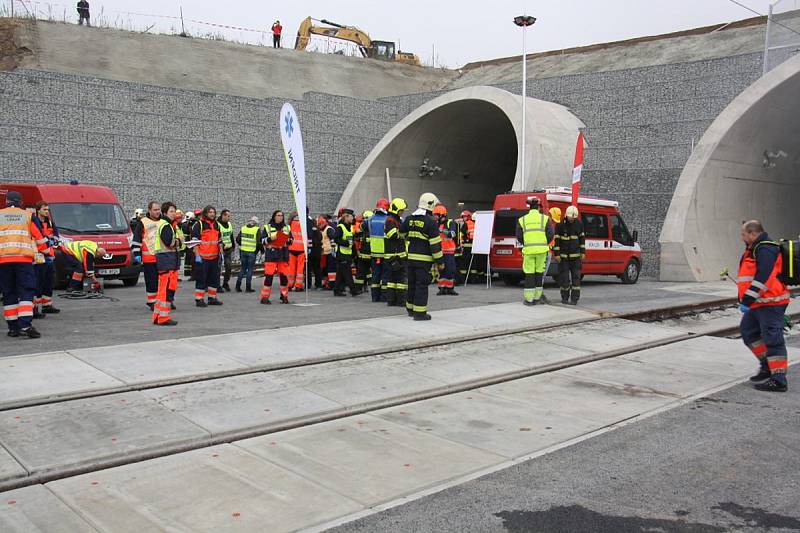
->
[0,192,585,338]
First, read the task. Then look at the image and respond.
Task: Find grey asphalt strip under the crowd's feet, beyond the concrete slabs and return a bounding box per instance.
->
[0,276,736,357]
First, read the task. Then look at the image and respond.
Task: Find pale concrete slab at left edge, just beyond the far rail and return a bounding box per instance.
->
[0,352,124,407]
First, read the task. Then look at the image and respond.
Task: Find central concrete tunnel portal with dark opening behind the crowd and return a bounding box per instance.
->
[339,87,583,214]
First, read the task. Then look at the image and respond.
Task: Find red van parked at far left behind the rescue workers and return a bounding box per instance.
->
[0,185,141,288]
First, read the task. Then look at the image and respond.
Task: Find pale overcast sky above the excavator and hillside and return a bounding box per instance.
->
[39,0,800,68]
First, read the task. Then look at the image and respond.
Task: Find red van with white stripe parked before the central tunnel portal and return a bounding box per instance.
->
[491,187,642,285]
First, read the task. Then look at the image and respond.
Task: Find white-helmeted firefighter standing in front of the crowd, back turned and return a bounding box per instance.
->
[400,192,444,320]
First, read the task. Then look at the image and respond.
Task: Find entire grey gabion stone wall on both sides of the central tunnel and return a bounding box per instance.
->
[0,54,761,275]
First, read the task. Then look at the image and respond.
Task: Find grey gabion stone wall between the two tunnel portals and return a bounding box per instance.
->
[383,54,761,276]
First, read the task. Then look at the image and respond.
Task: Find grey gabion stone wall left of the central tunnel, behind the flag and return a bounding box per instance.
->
[0,70,399,221]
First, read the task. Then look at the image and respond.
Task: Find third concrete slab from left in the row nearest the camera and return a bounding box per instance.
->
[236,415,503,507]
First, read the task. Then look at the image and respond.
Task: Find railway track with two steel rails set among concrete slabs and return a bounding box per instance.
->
[0,299,792,491]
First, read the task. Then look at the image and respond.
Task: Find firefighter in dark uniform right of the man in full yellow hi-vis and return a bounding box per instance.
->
[553,205,586,305]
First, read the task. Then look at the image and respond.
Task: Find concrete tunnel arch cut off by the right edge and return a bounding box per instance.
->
[659,52,800,281]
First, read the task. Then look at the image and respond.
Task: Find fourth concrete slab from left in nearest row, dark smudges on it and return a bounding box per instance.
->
[374,391,596,459]
